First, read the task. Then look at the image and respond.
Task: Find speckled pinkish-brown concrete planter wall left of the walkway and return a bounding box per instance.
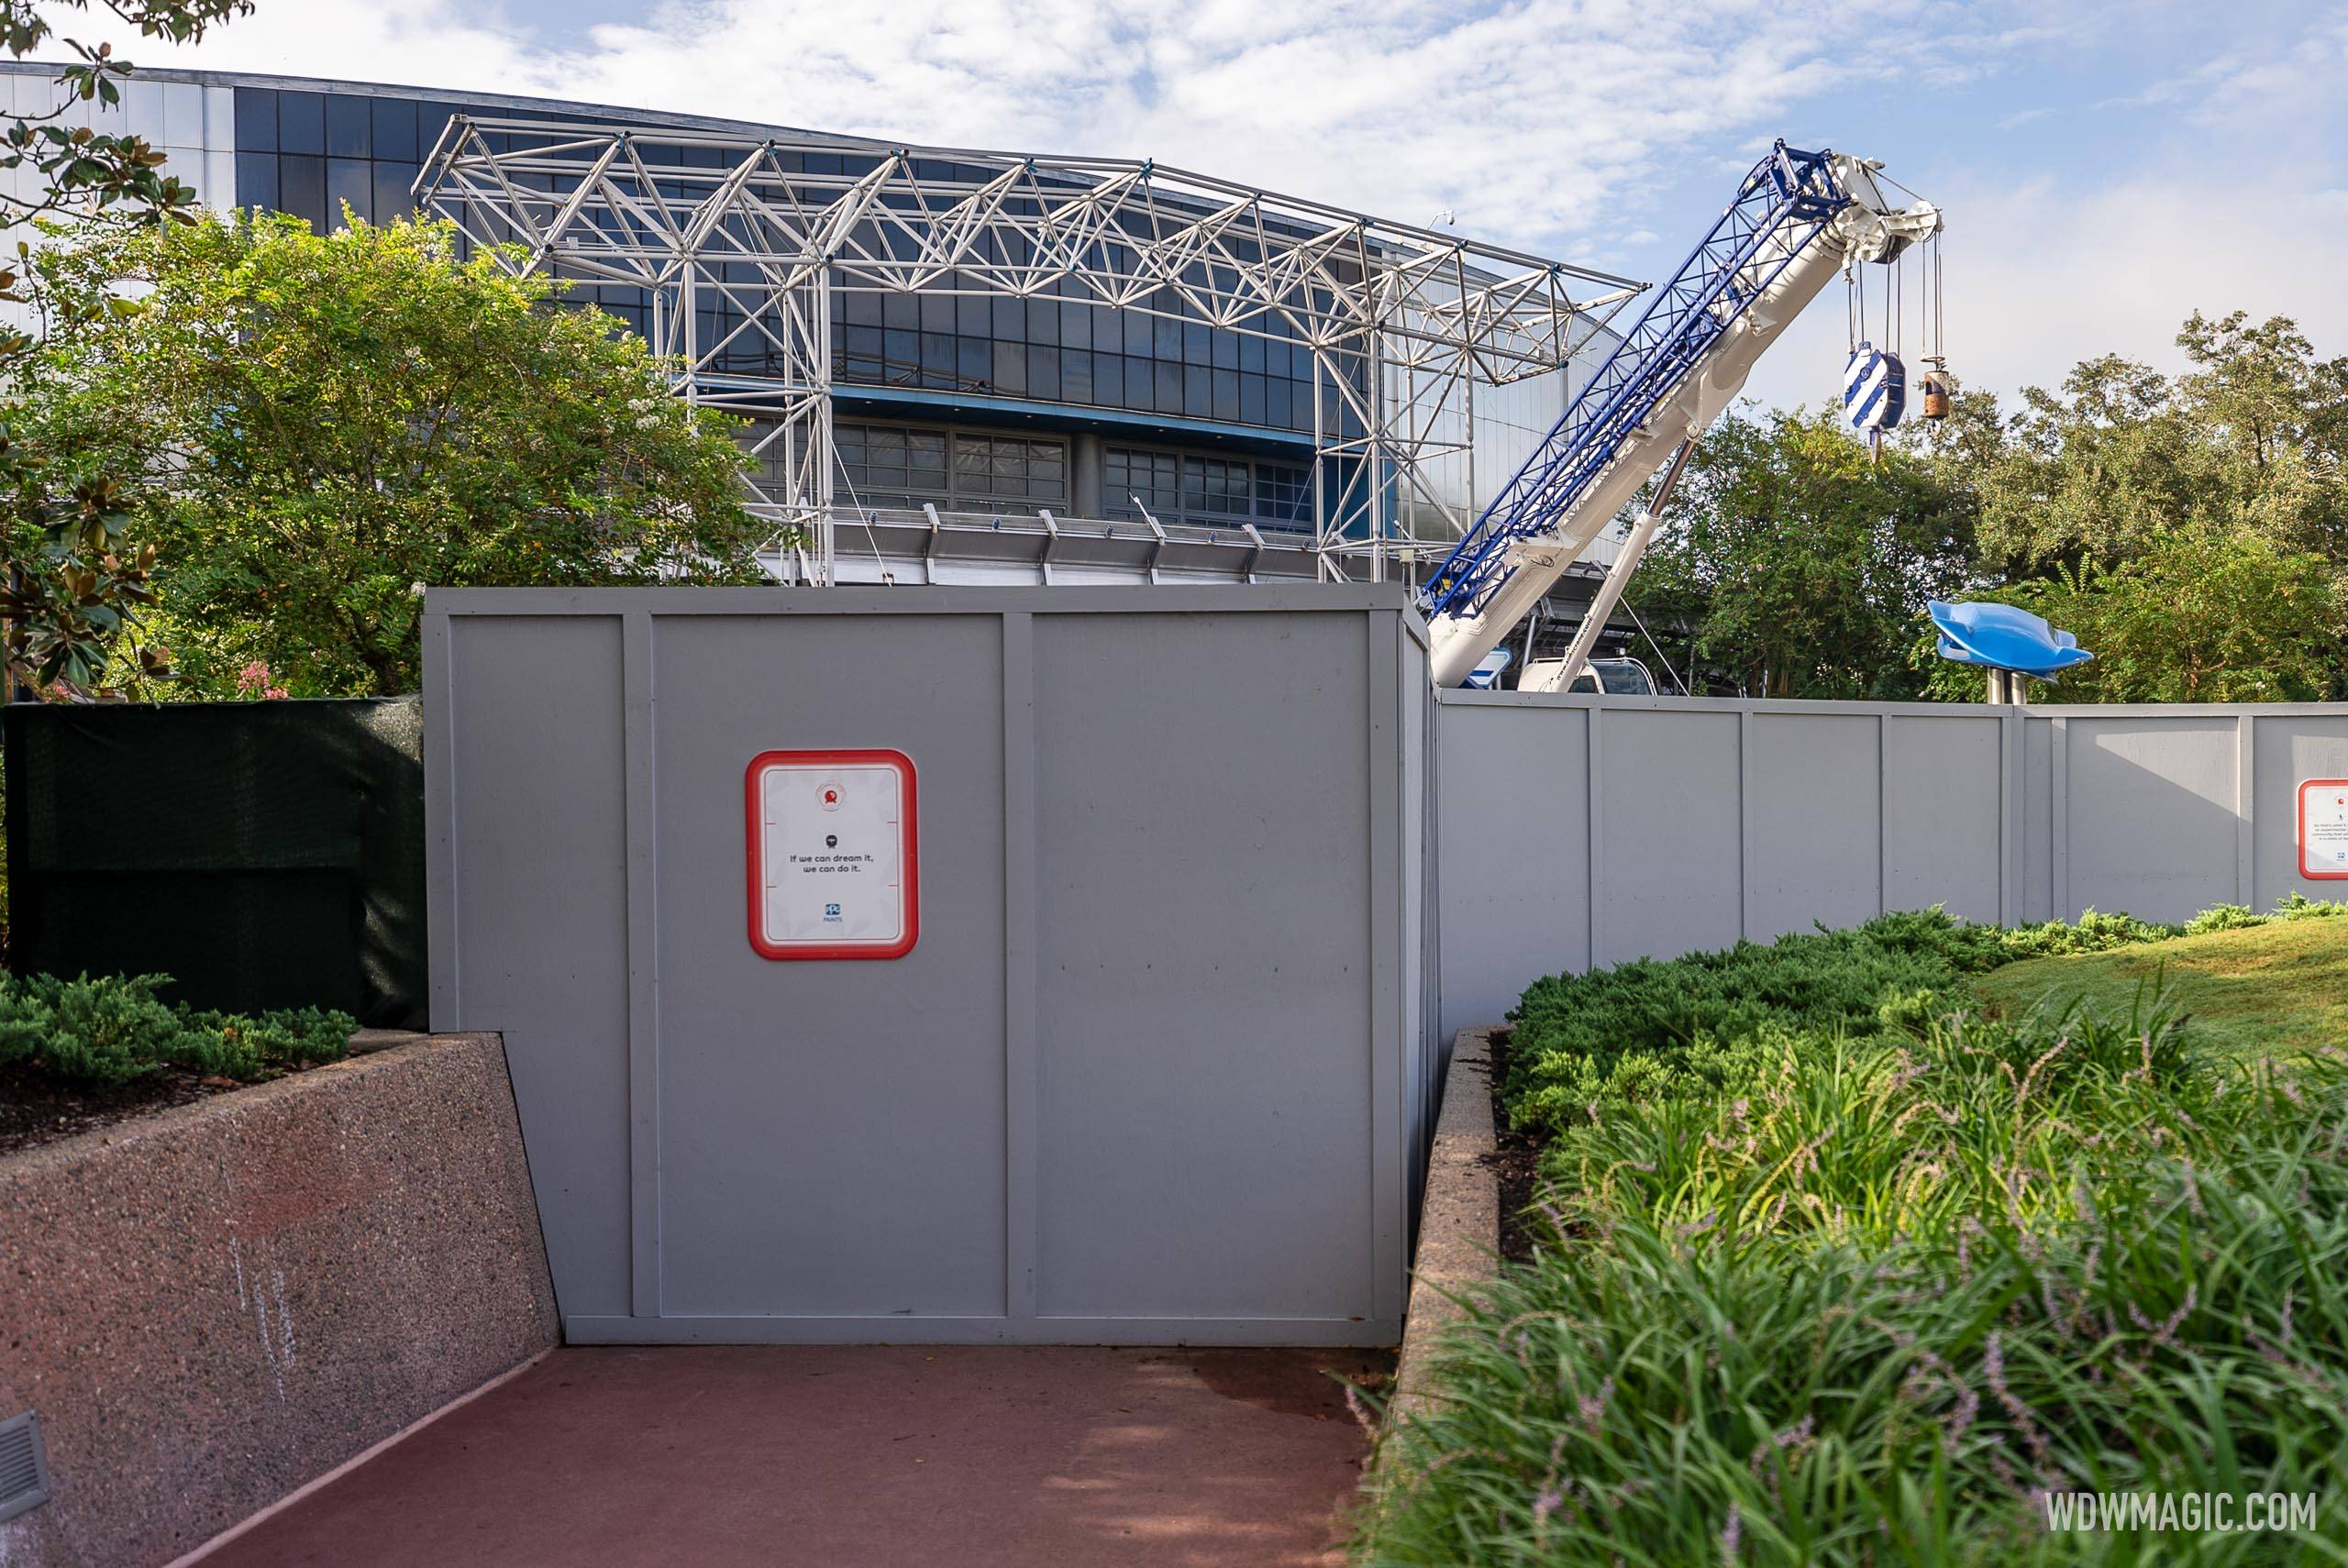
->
[0,1035,557,1568]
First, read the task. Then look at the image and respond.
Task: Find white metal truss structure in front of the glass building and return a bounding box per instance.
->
[415,115,1641,582]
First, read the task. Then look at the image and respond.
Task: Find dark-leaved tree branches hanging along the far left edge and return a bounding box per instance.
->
[0,0,253,690]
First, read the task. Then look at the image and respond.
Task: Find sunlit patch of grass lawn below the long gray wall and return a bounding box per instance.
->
[1972,920,2348,1054]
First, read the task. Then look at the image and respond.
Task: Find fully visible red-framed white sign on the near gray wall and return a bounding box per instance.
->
[742,751,921,957]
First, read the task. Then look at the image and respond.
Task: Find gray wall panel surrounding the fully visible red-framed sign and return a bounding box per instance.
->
[646,615,1005,1317]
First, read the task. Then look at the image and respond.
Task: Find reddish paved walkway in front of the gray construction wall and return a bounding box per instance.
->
[202,1345,1390,1568]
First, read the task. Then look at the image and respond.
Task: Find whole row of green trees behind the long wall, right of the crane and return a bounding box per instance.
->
[1634,312,2348,701]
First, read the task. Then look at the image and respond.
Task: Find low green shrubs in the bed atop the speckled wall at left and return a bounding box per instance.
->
[0,974,357,1085]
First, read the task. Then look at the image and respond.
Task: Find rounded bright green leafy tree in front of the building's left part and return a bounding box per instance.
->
[30,214,768,697]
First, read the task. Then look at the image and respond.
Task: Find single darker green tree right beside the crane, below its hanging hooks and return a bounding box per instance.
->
[1632,411,1972,697]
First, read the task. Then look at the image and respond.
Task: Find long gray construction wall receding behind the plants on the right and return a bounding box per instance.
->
[1437,692,2348,1035]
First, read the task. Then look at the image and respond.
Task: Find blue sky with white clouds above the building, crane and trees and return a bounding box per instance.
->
[105,0,2348,413]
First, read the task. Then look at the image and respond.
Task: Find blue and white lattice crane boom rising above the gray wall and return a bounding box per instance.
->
[1418,141,1940,685]
